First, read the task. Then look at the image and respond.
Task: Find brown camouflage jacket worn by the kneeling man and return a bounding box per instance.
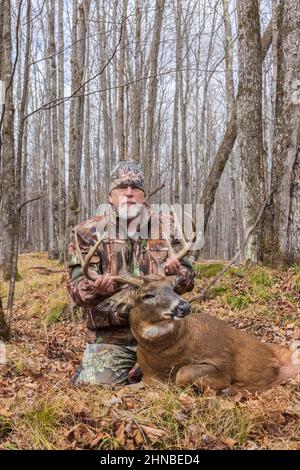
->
[67,211,194,344]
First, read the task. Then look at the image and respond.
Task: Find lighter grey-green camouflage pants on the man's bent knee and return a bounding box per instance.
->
[73,343,136,385]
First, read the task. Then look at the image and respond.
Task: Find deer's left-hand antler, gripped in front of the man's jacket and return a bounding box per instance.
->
[75,228,144,287]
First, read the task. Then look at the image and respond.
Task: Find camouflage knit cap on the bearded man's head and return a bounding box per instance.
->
[109,160,145,193]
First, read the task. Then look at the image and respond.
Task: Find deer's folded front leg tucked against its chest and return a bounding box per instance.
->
[175,364,231,390]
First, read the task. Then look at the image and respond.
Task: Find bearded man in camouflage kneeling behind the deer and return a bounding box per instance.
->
[67,160,194,386]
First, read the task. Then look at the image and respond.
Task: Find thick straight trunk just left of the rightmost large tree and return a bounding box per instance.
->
[237,0,266,262]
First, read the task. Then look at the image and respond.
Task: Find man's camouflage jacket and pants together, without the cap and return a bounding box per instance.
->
[67,209,195,384]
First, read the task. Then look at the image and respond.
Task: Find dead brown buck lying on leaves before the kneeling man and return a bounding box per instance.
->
[74,226,300,393]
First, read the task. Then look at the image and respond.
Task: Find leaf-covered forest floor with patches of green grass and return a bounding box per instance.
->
[0,253,300,450]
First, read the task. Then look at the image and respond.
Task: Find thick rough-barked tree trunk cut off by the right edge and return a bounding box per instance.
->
[263,0,300,267]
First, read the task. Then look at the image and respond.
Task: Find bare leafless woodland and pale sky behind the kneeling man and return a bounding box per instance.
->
[0,0,300,277]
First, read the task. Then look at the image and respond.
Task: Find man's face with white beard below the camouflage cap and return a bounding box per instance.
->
[109,186,145,220]
